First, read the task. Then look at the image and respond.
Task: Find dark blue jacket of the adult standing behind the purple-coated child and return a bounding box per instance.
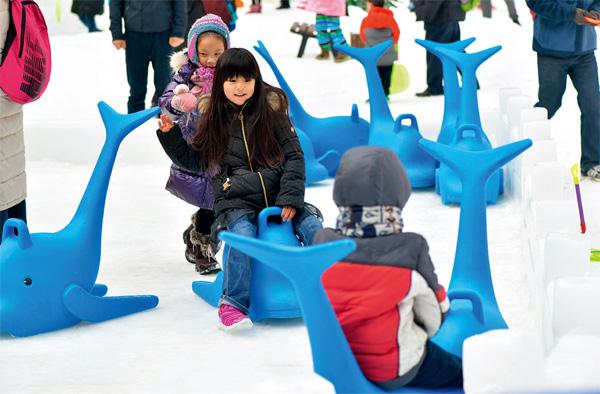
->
[110,0,187,40]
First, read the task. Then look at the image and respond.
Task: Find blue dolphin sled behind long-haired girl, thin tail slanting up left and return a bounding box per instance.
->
[254,41,369,176]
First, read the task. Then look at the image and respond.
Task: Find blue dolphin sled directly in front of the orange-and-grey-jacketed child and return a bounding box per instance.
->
[334,40,436,188]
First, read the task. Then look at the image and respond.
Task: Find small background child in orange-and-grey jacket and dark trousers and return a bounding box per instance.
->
[360,0,400,97]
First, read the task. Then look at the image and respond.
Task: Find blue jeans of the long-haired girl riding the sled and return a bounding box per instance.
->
[221,209,323,314]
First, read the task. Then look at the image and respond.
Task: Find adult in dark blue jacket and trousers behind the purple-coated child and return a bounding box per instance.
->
[110,0,187,113]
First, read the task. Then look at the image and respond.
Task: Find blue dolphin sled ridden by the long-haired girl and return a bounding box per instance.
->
[192,207,302,321]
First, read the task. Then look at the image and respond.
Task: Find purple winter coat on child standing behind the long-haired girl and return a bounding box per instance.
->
[158,61,214,209]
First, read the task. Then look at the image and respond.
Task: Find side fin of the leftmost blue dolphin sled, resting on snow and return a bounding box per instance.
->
[63,285,158,323]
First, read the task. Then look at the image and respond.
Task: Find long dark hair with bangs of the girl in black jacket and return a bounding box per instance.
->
[192,48,289,173]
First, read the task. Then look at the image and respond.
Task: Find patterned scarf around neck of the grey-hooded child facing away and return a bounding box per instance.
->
[335,205,403,238]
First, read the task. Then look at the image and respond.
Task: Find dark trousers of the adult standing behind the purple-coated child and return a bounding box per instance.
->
[125,30,173,113]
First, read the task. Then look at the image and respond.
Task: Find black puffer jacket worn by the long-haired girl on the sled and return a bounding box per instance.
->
[157,92,305,220]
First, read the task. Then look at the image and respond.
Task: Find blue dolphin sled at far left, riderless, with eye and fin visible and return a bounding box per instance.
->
[0,102,159,337]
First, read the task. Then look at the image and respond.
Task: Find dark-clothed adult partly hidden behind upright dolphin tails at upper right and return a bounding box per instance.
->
[413,0,465,97]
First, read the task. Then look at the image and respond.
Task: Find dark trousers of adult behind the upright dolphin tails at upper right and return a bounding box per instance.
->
[425,22,460,92]
